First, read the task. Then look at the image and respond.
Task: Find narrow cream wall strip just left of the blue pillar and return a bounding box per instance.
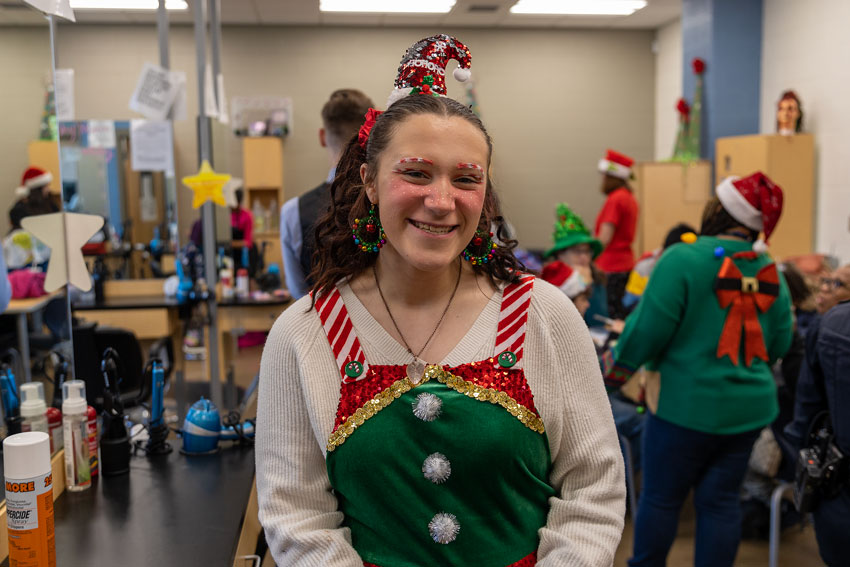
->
[655,19,682,160]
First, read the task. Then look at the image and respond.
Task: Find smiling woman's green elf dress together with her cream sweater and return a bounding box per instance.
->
[257,277,625,567]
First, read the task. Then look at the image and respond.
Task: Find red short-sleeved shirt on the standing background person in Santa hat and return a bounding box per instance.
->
[594,187,638,273]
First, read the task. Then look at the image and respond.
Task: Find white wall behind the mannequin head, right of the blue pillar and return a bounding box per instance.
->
[760,0,850,264]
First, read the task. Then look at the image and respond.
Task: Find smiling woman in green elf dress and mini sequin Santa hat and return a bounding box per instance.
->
[256,35,625,567]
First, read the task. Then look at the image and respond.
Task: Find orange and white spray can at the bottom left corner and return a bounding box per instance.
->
[3,431,56,567]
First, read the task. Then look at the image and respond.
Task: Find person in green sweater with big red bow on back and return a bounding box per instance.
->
[604,173,793,567]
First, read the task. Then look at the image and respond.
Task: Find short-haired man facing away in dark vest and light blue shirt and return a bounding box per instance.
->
[280,89,374,299]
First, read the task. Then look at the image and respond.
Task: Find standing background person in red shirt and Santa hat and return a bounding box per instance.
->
[594,150,638,319]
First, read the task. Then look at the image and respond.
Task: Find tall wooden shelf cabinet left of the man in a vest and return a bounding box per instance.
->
[242,137,284,269]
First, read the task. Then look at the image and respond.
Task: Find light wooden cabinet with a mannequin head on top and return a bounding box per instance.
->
[715,134,815,259]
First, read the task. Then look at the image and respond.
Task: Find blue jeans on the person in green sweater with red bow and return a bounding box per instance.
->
[629,415,760,567]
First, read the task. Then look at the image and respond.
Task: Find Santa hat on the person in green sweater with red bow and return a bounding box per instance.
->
[717,171,782,252]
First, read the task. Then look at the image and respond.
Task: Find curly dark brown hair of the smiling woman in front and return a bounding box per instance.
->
[308,95,525,301]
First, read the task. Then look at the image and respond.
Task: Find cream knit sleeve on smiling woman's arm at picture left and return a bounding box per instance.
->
[256,298,363,567]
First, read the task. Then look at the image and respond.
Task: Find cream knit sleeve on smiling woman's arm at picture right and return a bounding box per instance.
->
[526,280,626,567]
